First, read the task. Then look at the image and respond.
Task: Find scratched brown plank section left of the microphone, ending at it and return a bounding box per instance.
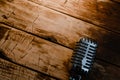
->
[0,25,72,79]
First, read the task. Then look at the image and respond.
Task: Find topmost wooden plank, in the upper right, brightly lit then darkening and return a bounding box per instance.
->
[29,0,120,33]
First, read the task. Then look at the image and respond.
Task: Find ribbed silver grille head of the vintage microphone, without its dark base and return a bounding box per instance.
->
[72,38,97,72]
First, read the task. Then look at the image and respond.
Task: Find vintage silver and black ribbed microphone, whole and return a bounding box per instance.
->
[69,37,97,80]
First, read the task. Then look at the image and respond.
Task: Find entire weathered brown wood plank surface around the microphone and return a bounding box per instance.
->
[0,0,120,80]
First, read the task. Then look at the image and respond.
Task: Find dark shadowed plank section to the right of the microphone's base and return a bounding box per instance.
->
[88,61,120,80]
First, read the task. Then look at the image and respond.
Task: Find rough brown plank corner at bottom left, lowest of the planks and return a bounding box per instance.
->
[0,58,55,80]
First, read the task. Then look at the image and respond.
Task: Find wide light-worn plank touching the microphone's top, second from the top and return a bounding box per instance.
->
[0,0,120,66]
